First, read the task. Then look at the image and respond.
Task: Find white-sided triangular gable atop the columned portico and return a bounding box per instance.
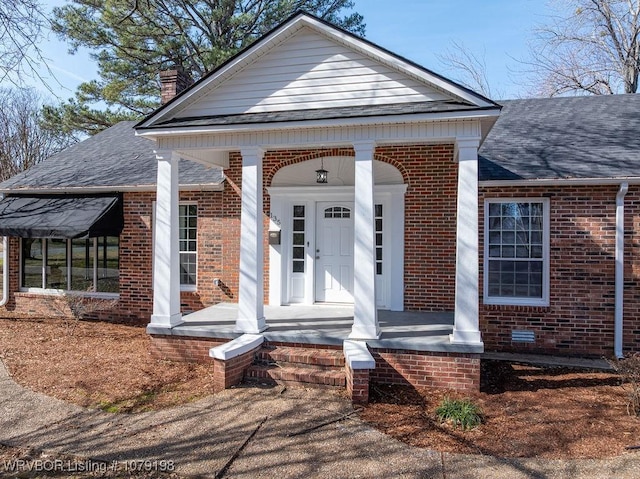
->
[138,13,496,127]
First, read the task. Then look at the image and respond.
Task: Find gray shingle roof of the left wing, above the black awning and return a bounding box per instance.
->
[0,121,223,191]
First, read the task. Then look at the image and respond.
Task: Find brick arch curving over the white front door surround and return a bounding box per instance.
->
[263,148,410,188]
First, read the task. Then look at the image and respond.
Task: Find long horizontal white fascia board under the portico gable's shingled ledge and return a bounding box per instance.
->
[136,108,500,138]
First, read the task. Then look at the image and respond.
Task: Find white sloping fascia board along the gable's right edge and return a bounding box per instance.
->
[302,17,496,107]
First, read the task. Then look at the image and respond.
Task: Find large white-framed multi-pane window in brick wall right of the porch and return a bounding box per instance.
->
[484,199,549,306]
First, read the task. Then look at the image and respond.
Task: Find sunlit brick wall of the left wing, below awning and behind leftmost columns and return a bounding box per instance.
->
[0,191,229,324]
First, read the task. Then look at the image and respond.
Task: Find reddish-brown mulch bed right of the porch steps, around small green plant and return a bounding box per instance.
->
[361,361,640,460]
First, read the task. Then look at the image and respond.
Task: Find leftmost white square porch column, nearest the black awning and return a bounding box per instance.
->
[151,151,182,327]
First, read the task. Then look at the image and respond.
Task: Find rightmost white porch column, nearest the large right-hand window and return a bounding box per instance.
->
[451,139,482,344]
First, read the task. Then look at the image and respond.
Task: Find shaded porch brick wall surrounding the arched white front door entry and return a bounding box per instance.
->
[262,144,458,311]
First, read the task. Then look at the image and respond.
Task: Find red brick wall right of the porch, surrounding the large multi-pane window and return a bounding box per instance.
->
[480,186,640,356]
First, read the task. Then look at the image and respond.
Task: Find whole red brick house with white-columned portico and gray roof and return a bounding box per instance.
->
[0,13,640,400]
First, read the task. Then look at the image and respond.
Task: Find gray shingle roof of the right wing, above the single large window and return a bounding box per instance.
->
[479,94,640,181]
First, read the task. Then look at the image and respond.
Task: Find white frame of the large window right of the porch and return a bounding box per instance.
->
[483,197,551,306]
